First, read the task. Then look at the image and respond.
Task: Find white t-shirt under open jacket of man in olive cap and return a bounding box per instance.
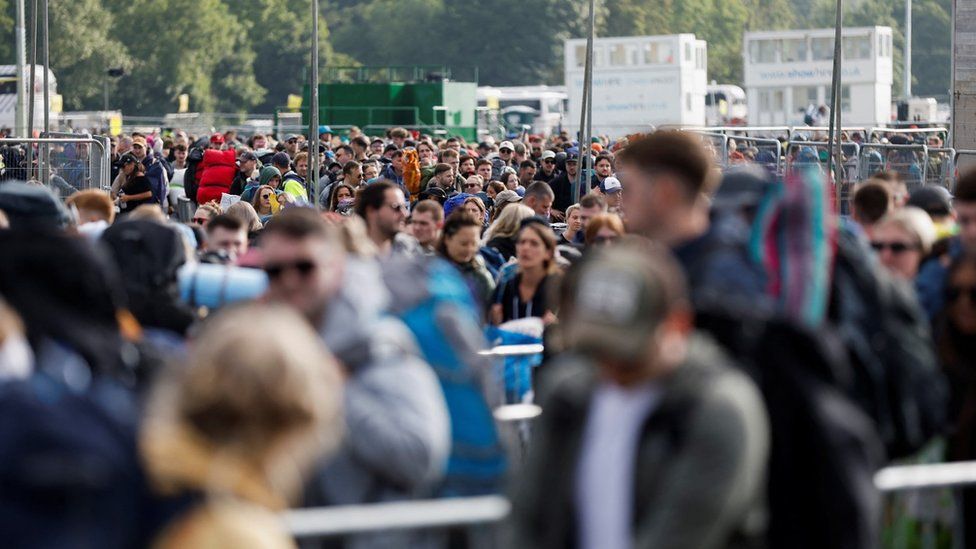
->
[574,383,661,549]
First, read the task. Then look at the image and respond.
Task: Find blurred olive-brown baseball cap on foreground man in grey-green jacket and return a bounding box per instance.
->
[560,241,687,361]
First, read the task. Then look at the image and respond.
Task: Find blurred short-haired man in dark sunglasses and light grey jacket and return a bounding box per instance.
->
[261,207,450,528]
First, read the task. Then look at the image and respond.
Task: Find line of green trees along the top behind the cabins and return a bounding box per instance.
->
[0,0,951,115]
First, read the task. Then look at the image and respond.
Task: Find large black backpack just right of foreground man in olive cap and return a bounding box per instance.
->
[696,305,884,549]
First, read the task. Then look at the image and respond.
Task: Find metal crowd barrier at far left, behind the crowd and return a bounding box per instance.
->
[0,136,112,198]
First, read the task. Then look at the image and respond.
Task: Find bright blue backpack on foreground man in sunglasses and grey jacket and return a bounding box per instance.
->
[383,257,507,497]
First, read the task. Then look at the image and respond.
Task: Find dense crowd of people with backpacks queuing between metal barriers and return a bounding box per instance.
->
[0,126,976,549]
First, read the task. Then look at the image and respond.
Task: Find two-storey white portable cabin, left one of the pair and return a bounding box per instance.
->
[564,34,708,137]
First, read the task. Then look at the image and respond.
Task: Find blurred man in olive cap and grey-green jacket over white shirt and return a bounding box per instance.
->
[512,242,769,549]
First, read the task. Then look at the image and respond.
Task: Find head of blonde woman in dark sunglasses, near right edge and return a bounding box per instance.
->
[871,206,935,281]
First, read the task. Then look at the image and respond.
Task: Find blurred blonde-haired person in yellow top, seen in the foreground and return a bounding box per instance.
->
[140,304,342,549]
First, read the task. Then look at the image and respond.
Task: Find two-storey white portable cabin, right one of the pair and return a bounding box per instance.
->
[743,27,893,126]
